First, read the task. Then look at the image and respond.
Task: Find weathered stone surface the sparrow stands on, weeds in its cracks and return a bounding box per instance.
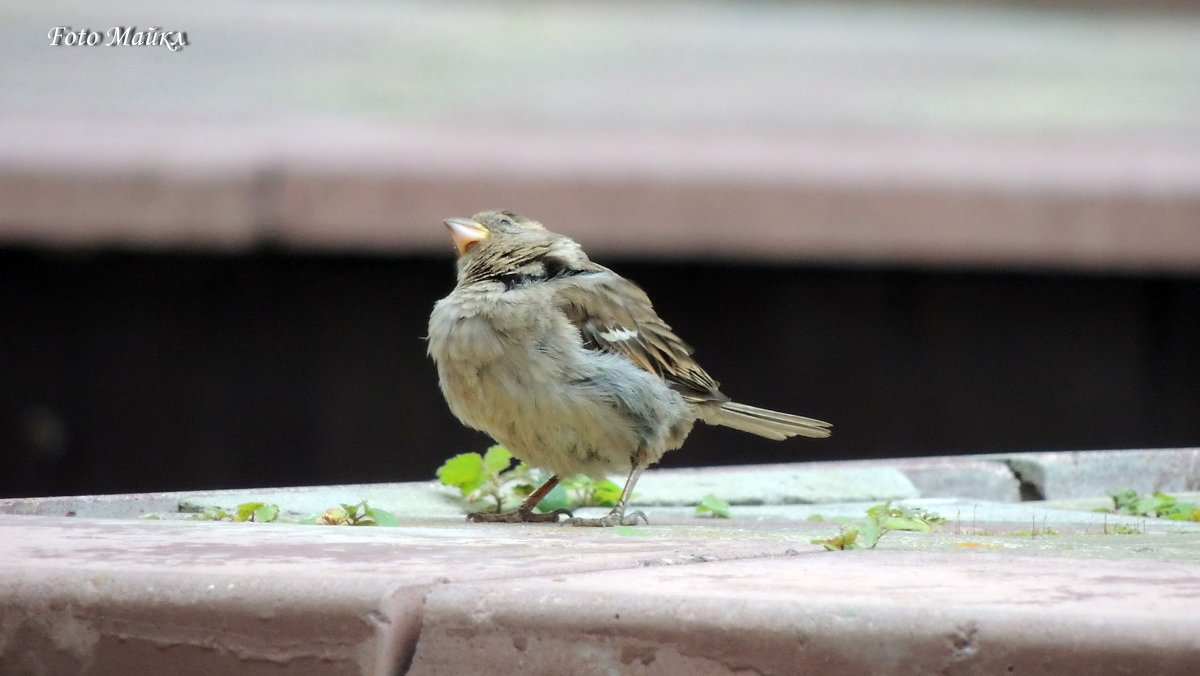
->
[0,449,1200,676]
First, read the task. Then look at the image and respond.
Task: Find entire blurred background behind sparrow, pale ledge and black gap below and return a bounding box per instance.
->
[0,0,1200,496]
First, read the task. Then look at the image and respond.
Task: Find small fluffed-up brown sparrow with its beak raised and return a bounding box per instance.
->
[428,211,830,526]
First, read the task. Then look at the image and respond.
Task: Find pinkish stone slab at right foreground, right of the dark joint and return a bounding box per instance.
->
[410,551,1200,676]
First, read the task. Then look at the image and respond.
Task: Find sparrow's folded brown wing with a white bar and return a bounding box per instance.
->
[554,262,728,402]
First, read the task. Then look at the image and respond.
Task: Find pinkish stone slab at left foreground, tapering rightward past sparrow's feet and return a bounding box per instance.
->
[0,515,806,675]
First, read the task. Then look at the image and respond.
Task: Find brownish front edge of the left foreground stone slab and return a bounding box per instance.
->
[0,564,408,675]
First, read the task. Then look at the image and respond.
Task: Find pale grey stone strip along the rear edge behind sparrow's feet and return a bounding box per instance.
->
[0,448,1200,519]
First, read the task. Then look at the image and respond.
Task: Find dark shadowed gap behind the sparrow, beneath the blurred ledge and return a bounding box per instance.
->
[0,249,1200,496]
